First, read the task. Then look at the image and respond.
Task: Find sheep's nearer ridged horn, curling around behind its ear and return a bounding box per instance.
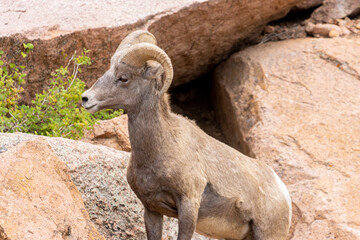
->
[121,43,174,95]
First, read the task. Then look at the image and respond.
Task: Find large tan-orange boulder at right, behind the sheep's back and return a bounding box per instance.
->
[214,39,360,240]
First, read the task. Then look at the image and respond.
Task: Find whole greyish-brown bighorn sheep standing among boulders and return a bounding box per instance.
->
[82,30,291,240]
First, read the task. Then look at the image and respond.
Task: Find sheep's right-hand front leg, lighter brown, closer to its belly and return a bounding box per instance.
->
[177,198,199,240]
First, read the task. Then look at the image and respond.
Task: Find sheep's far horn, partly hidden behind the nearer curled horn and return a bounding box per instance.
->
[111,30,157,65]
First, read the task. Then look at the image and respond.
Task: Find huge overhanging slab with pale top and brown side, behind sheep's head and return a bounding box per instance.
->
[0,0,308,103]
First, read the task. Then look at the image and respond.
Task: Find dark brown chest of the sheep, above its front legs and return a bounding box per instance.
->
[127,160,177,217]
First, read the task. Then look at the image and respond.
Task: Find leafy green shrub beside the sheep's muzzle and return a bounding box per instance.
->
[0,44,122,139]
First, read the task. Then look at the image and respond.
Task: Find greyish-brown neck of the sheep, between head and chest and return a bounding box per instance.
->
[128,96,171,161]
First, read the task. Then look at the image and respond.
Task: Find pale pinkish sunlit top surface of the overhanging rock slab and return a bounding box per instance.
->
[0,0,204,39]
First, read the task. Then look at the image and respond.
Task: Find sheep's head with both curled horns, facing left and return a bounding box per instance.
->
[82,31,173,113]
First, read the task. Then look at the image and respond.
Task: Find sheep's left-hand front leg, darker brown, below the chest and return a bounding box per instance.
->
[144,208,163,240]
